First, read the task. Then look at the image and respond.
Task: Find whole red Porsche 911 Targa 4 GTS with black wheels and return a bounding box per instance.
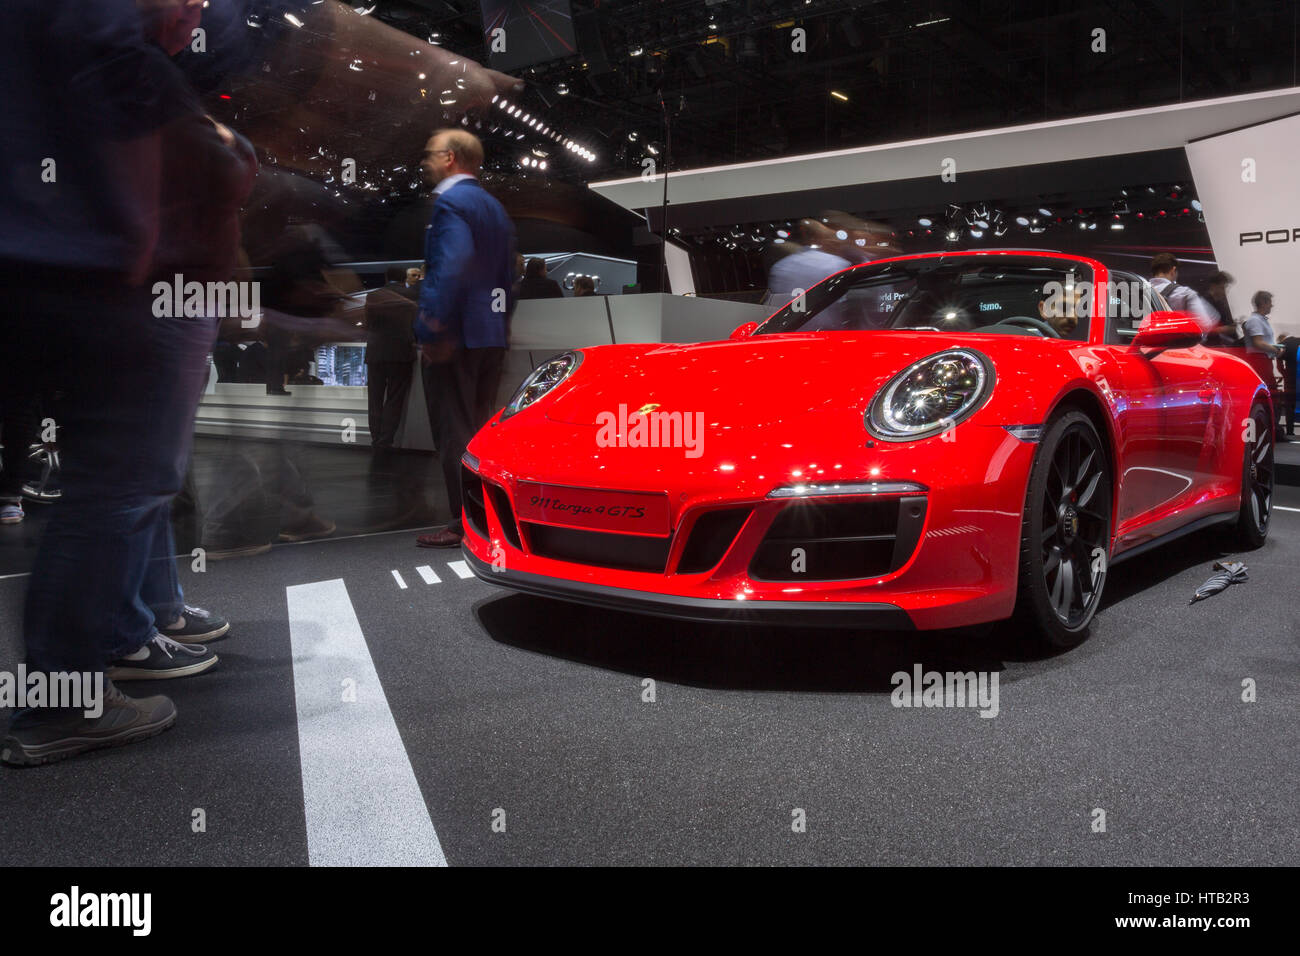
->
[462,251,1274,646]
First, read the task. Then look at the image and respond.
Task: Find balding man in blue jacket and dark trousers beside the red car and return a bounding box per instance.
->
[415,129,515,548]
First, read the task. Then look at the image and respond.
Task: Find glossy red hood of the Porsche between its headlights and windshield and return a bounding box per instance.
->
[546,332,1045,428]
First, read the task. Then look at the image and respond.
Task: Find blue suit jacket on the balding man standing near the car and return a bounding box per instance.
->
[416,179,515,349]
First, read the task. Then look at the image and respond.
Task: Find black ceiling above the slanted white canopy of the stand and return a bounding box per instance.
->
[379,0,1297,182]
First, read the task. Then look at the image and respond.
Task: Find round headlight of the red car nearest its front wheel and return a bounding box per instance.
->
[866,349,993,441]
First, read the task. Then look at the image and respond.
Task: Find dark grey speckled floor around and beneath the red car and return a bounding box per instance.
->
[0,488,1300,866]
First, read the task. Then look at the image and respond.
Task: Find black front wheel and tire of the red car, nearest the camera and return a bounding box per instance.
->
[1014,410,1113,650]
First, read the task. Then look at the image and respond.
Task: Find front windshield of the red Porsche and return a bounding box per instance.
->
[755,255,1093,342]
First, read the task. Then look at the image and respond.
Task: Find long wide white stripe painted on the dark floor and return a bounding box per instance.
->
[285,579,447,866]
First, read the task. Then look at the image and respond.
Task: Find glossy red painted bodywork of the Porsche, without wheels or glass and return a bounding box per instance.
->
[463,252,1268,630]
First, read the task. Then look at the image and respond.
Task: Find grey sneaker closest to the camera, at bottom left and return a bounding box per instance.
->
[0,680,176,766]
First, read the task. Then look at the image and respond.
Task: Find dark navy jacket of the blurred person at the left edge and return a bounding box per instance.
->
[0,0,203,278]
